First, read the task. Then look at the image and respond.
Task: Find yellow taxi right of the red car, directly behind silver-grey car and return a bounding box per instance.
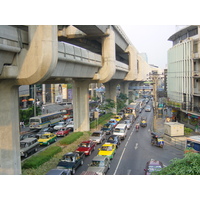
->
[98,143,116,159]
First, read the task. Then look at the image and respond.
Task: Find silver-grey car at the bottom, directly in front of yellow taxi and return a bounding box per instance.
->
[87,156,110,175]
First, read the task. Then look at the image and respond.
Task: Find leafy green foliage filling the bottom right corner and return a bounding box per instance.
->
[153,152,200,175]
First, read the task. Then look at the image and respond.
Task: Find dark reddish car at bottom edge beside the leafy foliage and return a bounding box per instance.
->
[144,159,163,175]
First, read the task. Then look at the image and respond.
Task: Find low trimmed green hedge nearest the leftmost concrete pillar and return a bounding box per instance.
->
[22,146,62,169]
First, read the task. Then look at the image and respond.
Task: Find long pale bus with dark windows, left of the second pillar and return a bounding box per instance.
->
[29,112,63,130]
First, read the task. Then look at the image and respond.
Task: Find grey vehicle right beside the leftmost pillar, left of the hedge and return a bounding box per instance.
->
[20,138,40,158]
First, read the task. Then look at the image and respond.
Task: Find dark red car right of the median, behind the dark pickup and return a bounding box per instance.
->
[76,140,96,156]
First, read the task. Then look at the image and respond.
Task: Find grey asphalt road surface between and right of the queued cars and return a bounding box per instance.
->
[76,104,183,175]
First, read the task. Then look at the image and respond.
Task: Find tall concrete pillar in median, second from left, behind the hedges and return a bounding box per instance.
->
[73,80,90,131]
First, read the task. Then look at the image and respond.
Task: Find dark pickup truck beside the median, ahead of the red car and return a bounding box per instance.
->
[57,152,85,174]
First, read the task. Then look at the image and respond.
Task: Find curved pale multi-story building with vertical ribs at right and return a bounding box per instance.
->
[167,25,200,125]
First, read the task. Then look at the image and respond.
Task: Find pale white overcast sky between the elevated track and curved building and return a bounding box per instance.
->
[120,25,177,68]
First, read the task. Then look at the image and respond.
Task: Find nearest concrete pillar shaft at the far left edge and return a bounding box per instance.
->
[0,80,21,175]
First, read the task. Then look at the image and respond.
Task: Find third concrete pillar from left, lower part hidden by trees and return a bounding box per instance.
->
[104,80,120,114]
